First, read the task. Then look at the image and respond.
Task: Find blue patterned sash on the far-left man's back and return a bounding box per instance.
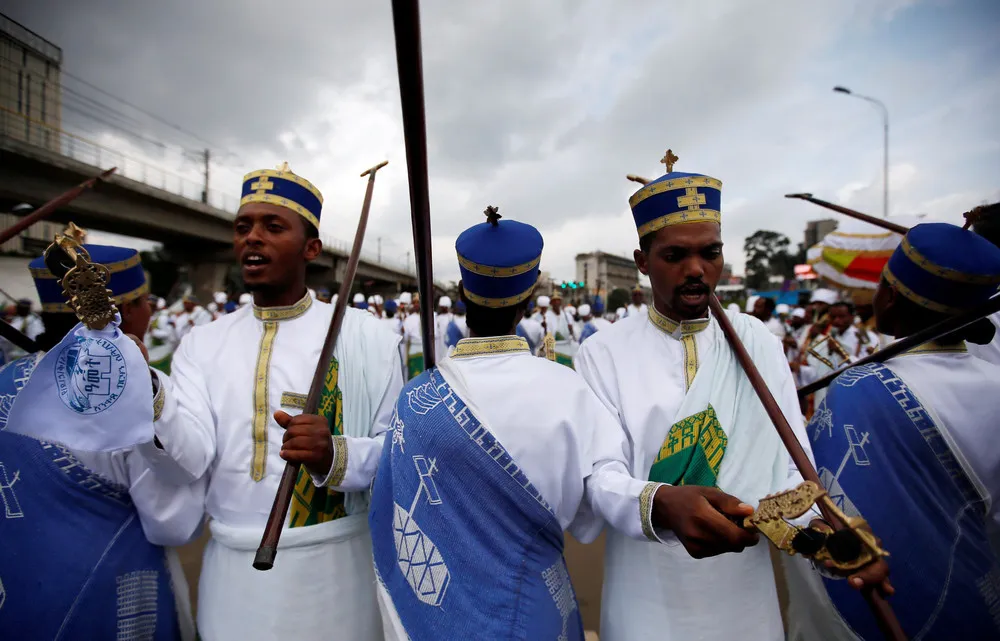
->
[0,356,180,641]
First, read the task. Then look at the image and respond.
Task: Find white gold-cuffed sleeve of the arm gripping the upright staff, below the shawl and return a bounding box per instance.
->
[312,330,403,492]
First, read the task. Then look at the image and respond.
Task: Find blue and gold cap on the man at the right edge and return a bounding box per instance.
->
[882,223,1000,314]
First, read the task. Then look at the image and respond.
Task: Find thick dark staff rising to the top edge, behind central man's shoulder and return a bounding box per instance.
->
[392,0,436,369]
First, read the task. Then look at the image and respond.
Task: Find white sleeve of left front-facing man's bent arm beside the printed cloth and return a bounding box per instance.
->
[138,335,216,485]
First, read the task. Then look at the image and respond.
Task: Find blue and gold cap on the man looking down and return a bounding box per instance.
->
[628,149,722,238]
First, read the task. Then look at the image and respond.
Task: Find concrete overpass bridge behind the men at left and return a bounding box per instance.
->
[0,127,443,302]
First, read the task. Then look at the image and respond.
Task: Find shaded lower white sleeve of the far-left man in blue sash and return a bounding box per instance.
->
[127,453,206,546]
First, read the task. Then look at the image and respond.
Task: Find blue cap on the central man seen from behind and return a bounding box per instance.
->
[455,207,543,308]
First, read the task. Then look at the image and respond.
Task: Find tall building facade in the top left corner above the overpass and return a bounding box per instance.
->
[0,14,62,152]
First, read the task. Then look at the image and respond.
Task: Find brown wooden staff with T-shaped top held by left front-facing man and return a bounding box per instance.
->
[253,160,389,571]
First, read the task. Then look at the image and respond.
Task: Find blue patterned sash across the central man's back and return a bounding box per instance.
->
[369,369,583,641]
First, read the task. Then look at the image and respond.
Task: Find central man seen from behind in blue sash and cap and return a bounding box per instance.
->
[370,208,668,641]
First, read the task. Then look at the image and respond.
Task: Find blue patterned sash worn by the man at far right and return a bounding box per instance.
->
[808,364,1000,639]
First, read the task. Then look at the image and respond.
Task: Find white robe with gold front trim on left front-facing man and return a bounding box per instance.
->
[143,295,403,641]
